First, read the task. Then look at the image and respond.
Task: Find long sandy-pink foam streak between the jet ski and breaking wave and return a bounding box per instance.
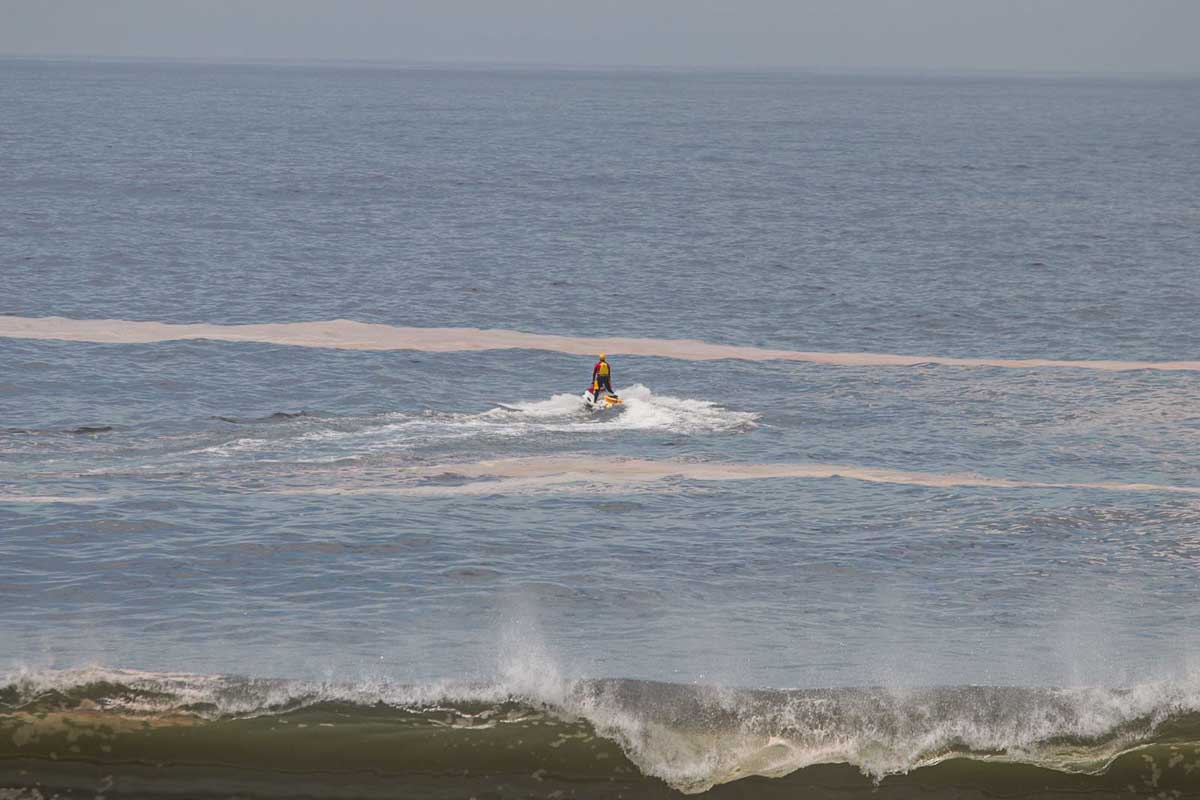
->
[283,456,1200,497]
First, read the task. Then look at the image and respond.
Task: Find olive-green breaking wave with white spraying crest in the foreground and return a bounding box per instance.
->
[0,669,1200,796]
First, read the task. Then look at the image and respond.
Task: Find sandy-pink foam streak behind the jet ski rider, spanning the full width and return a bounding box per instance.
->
[0,315,1200,372]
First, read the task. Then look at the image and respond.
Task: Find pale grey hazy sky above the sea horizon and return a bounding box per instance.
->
[0,0,1200,72]
